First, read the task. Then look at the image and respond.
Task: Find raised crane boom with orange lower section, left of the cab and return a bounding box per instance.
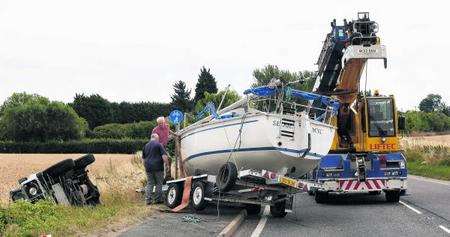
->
[313,12,395,151]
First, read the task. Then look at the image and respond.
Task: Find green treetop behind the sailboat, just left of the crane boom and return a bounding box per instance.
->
[252,65,315,91]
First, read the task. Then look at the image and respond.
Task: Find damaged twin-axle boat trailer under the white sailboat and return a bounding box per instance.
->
[163,162,303,217]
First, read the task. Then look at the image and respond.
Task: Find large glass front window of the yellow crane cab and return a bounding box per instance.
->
[367,98,395,137]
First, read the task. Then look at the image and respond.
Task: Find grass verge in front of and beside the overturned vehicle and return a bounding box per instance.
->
[0,154,152,236]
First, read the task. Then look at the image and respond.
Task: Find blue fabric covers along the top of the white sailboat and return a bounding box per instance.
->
[244,86,340,112]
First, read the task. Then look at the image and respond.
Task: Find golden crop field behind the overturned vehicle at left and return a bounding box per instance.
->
[0,154,144,203]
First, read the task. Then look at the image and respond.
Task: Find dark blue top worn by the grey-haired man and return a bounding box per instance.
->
[142,141,166,172]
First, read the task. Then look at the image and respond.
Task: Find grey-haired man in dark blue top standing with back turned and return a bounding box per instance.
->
[142,133,169,205]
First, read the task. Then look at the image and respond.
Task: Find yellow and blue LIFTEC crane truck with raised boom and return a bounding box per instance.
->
[307,12,407,203]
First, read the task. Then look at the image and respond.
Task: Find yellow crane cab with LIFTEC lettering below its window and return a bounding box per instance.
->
[331,94,404,152]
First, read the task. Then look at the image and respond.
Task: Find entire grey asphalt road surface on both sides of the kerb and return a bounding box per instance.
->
[122,176,450,237]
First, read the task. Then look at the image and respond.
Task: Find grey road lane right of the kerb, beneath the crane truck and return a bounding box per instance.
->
[236,176,450,237]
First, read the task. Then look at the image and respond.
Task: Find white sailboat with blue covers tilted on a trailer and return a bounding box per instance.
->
[179,82,339,177]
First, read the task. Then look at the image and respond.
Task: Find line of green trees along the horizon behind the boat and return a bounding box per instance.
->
[0,65,444,142]
